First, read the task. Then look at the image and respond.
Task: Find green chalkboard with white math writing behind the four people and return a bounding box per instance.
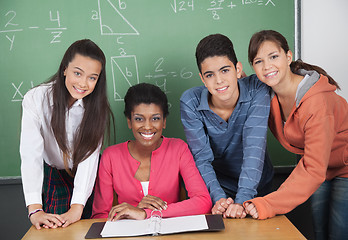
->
[0,0,295,177]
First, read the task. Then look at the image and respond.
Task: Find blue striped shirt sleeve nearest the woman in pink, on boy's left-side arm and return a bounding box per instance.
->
[180,90,226,204]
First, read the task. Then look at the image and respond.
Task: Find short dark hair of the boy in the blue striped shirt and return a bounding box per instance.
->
[196,34,238,73]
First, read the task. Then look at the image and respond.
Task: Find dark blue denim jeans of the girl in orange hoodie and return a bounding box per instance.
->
[311,177,348,240]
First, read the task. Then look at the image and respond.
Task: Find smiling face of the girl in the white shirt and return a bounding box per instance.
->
[64,54,102,106]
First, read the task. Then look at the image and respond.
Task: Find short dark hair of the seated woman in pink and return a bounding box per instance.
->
[124,83,169,119]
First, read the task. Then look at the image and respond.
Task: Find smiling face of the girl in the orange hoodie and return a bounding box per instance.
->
[252,41,292,87]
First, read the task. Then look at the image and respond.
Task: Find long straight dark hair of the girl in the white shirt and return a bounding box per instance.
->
[48,39,114,175]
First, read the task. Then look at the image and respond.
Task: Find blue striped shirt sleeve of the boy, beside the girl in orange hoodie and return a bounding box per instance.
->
[234,75,270,204]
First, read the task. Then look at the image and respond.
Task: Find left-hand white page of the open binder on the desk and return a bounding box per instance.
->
[100,219,152,237]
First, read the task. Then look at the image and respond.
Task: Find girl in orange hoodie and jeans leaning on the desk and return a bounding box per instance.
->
[244,30,348,239]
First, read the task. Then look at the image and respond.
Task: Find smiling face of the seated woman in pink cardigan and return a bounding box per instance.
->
[127,103,166,150]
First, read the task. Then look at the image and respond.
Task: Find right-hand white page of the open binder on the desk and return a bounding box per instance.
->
[160,215,208,234]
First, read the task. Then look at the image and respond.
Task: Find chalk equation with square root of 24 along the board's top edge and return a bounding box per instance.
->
[170,0,277,20]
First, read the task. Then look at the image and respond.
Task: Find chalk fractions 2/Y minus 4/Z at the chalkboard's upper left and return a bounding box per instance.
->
[0,10,67,51]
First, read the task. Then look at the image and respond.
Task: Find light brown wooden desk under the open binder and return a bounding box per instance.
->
[23,215,306,240]
